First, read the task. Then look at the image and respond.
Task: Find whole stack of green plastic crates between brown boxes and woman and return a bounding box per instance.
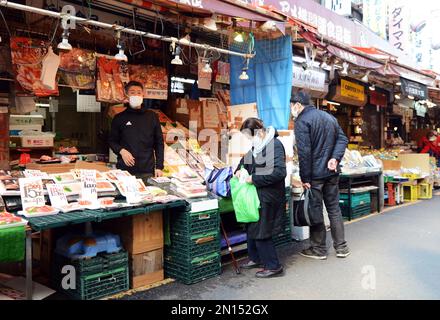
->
[164,208,221,284]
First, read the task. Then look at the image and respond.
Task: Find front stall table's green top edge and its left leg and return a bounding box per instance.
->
[19,200,186,300]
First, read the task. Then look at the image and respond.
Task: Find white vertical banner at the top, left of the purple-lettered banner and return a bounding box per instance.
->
[362,0,388,39]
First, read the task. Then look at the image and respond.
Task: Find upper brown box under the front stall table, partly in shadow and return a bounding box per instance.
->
[102,211,164,255]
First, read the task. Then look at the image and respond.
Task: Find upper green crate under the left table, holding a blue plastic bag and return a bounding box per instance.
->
[54,251,128,276]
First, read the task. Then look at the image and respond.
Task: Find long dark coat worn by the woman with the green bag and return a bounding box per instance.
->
[237,134,287,239]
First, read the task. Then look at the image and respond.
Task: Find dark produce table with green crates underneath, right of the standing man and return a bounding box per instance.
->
[339,171,384,221]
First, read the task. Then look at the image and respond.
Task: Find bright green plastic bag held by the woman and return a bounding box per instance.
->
[231,177,260,223]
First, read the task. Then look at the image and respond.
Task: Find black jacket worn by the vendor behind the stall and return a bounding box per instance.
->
[109,106,164,174]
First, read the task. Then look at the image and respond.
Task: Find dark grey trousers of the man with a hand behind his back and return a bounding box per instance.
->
[310,176,347,254]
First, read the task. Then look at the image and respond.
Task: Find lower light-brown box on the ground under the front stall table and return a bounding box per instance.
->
[130,248,164,289]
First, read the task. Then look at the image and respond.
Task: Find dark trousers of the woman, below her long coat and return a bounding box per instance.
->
[247,237,281,270]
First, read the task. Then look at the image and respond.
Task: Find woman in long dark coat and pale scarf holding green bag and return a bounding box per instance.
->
[236,118,287,278]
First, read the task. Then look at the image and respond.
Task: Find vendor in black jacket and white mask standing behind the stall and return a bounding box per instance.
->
[109,81,164,182]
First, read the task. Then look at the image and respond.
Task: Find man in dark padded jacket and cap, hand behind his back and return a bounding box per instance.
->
[292,91,350,260]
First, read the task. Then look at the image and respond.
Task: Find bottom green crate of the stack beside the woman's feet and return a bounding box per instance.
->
[164,252,221,285]
